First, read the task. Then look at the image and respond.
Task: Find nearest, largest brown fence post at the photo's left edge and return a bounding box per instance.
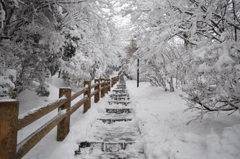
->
[0,100,19,159]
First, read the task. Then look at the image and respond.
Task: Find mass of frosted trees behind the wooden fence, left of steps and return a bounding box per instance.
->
[0,0,123,98]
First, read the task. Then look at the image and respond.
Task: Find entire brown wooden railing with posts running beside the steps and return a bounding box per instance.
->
[0,73,120,159]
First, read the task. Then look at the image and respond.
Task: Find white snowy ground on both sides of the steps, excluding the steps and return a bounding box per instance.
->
[18,78,240,159]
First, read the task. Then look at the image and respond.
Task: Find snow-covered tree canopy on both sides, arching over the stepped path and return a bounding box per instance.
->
[0,0,240,115]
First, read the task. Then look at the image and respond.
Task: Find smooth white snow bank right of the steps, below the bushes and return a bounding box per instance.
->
[127,81,240,159]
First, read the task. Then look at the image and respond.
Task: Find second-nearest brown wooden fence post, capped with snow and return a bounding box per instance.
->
[57,88,72,141]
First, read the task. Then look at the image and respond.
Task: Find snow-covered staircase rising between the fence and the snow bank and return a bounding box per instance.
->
[75,77,145,159]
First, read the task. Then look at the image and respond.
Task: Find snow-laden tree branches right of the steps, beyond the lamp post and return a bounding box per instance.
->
[123,0,240,114]
